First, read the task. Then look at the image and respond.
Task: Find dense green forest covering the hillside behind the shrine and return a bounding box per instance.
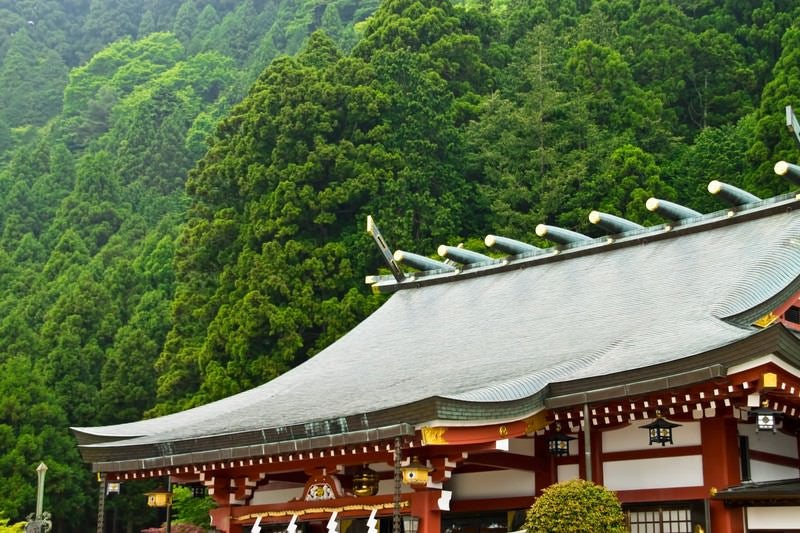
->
[0,0,800,532]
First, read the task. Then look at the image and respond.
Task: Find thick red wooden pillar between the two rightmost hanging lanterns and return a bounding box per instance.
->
[700,417,744,533]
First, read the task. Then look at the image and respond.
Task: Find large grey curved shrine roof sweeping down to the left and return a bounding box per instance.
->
[74,194,800,462]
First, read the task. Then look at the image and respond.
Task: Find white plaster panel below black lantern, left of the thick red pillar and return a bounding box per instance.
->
[603,455,703,490]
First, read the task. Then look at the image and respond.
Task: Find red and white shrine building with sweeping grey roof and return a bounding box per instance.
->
[73,162,800,533]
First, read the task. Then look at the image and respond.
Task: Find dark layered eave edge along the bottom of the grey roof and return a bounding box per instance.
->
[73,324,800,472]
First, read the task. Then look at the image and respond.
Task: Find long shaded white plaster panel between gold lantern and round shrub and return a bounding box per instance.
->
[454,470,536,500]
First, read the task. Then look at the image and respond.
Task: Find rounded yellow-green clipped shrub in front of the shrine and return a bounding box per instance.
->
[525,479,626,533]
